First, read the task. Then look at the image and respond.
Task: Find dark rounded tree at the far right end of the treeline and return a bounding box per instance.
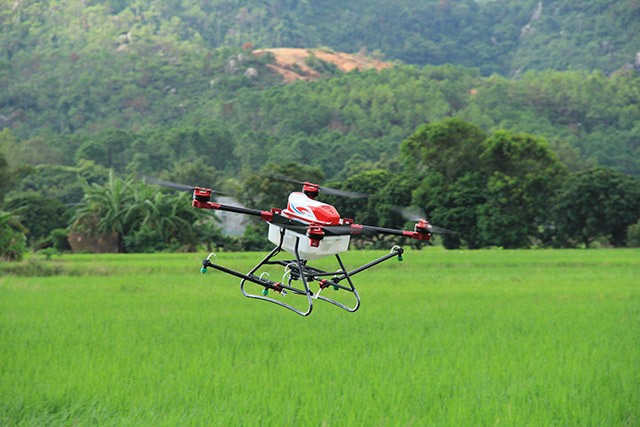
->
[553,167,640,248]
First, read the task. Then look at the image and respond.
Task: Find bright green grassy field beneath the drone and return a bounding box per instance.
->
[0,248,640,426]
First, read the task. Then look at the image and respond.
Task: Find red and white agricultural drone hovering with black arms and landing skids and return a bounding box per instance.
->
[152,178,454,316]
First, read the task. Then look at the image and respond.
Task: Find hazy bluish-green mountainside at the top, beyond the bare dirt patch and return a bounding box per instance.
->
[2,0,640,75]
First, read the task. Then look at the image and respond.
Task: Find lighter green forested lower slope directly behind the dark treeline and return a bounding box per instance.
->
[0,66,640,184]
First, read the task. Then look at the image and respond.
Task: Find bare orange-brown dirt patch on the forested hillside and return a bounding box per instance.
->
[253,48,393,83]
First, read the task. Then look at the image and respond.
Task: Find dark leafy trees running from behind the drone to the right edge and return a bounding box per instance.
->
[236,118,640,249]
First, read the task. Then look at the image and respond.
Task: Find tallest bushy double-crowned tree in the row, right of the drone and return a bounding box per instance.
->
[402,119,565,248]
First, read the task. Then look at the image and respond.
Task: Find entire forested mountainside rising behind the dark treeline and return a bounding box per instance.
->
[0,0,640,254]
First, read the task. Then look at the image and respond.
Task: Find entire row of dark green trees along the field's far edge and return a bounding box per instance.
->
[0,118,640,259]
